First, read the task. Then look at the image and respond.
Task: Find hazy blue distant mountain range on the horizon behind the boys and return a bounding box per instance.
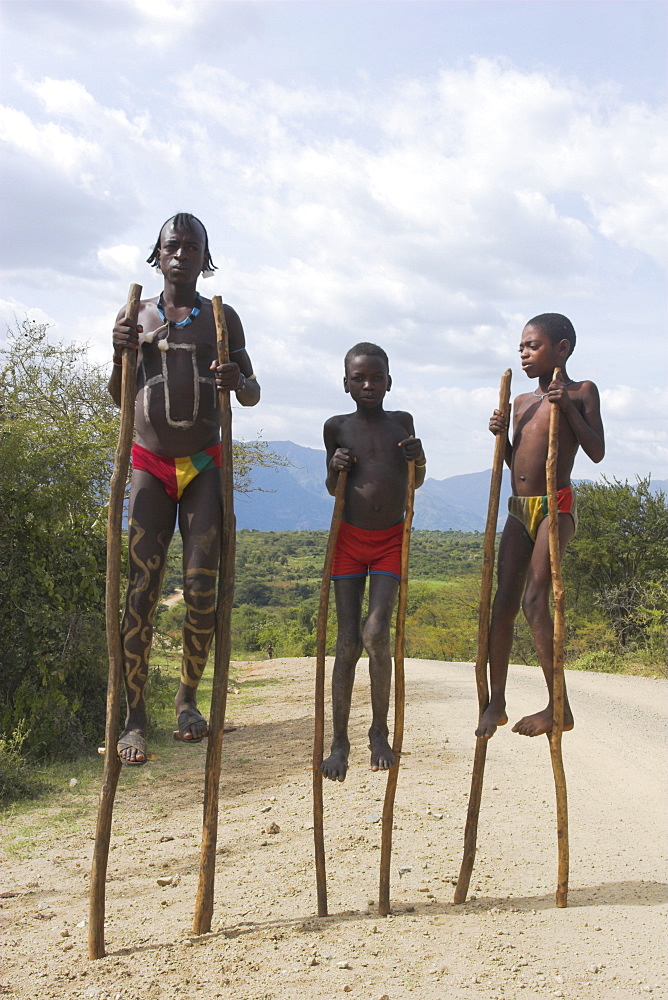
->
[235,441,668,531]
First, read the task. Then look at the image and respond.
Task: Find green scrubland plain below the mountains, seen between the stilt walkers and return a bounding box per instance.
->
[156,531,482,660]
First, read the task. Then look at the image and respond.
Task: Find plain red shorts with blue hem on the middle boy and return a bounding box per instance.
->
[332,521,404,580]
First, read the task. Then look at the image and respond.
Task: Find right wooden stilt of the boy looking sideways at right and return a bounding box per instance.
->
[545,368,569,907]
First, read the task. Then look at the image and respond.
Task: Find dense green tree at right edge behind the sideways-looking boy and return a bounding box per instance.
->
[564,477,668,652]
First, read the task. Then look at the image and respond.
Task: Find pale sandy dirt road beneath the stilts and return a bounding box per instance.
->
[0,659,668,1000]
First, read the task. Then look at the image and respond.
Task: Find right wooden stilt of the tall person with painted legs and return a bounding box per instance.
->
[193,295,236,934]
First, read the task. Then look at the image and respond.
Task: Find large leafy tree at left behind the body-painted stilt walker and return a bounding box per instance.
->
[0,319,288,756]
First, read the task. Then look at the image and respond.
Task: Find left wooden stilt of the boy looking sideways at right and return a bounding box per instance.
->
[455,368,512,903]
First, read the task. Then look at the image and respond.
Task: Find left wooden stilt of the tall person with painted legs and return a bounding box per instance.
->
[88,284,142,958]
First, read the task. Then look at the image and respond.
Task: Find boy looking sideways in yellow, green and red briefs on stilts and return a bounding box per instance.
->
[476,313,605,739]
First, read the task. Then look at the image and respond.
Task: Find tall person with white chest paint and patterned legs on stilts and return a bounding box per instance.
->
[109,213,260,765]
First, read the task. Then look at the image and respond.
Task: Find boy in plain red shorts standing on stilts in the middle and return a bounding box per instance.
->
[320,343,427,781]
